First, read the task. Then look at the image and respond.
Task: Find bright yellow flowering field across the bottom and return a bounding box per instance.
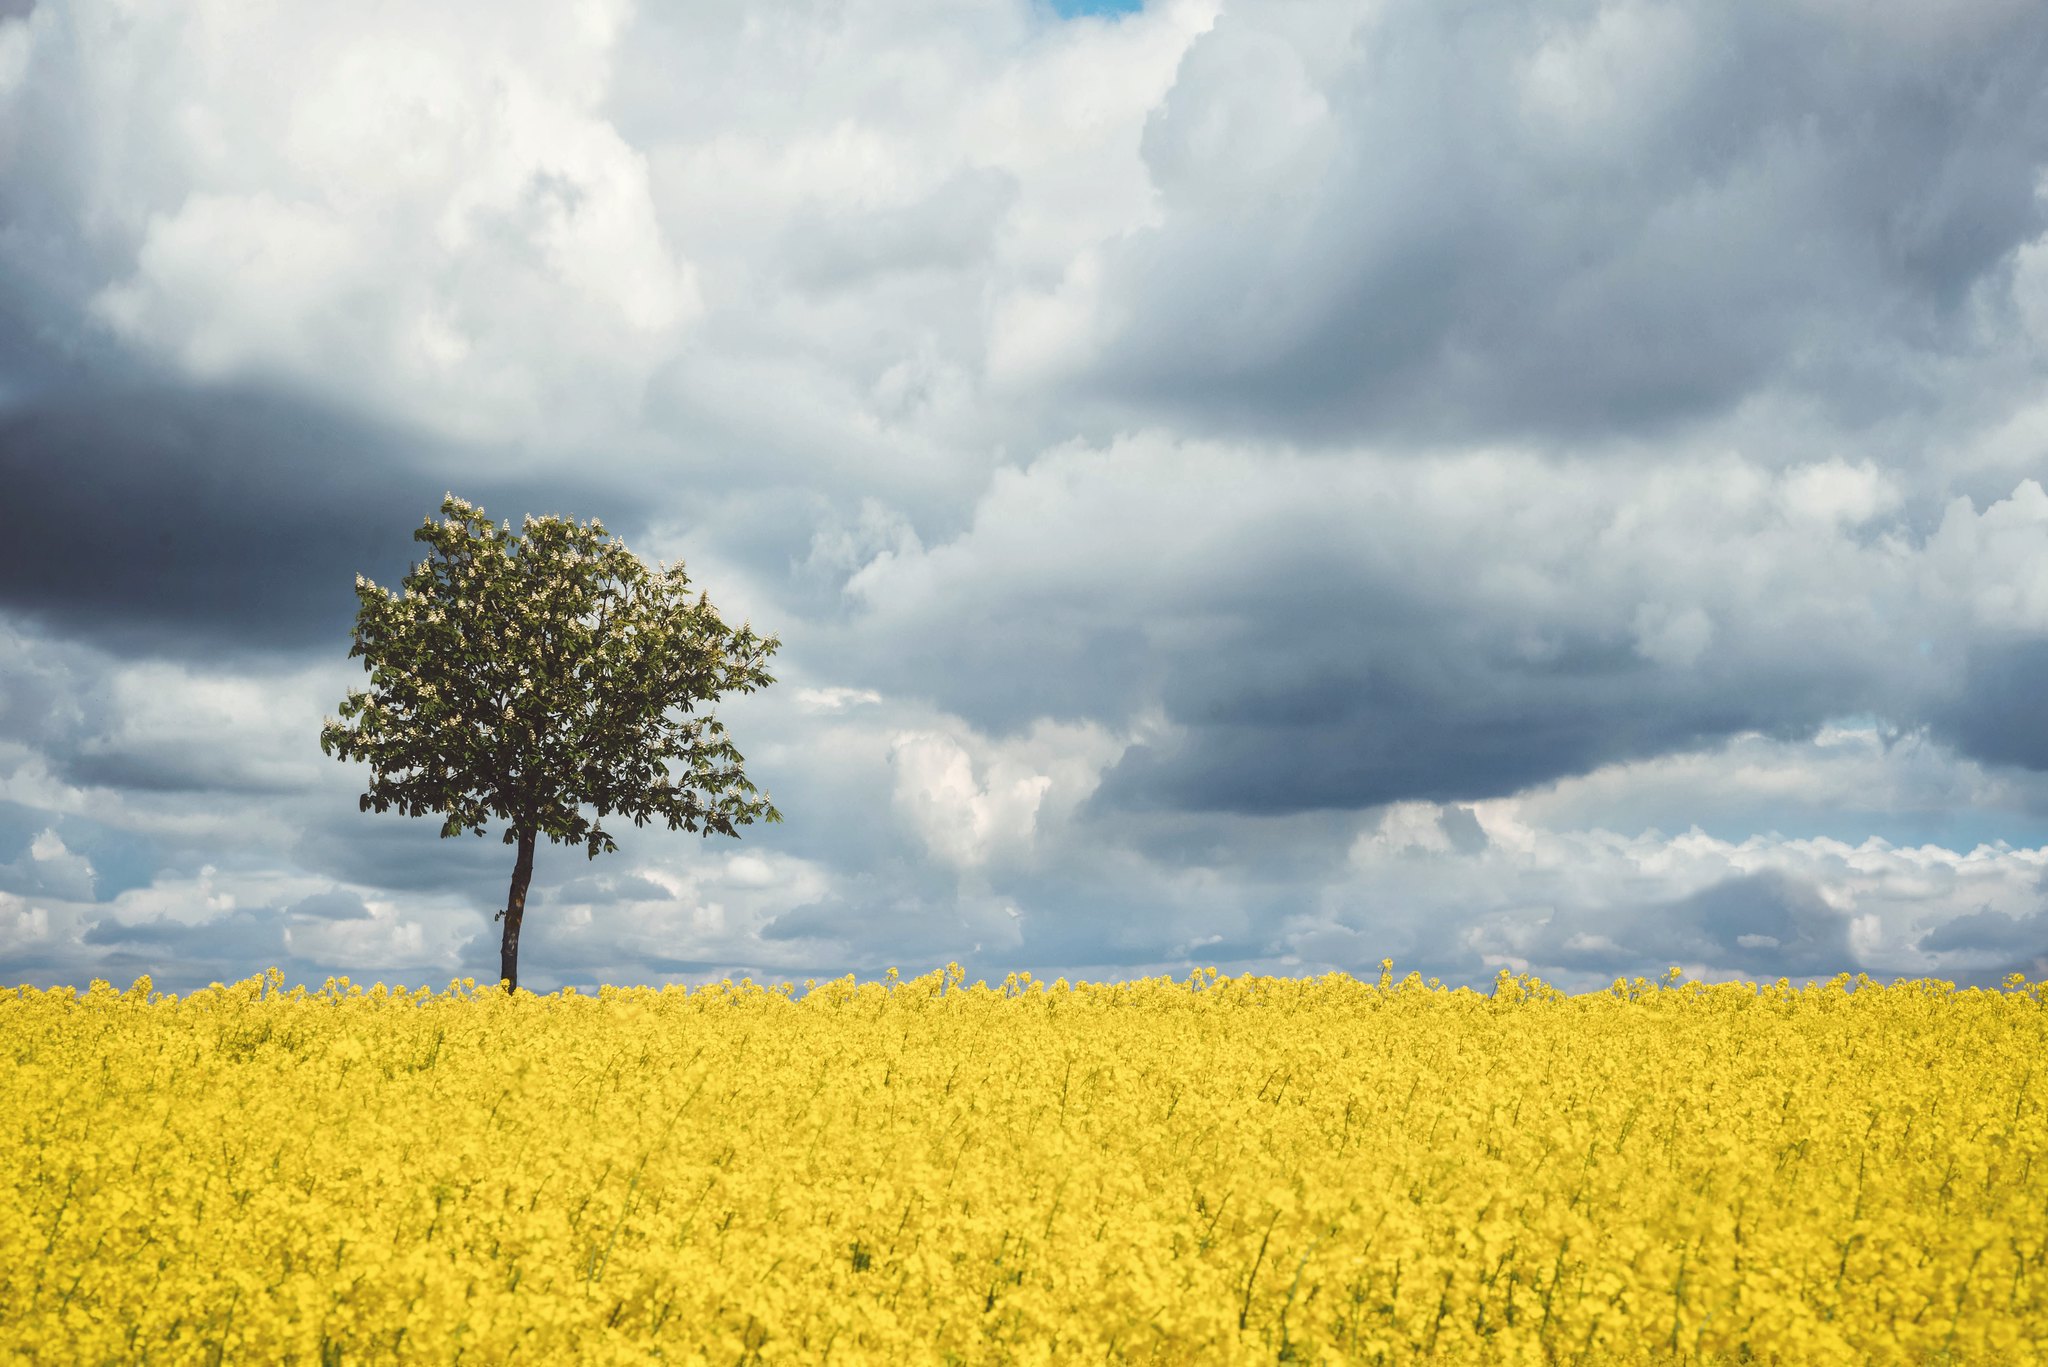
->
[0,969,2048,1363]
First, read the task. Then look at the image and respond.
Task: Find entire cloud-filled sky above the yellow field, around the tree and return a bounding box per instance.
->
[0,0,2048,992]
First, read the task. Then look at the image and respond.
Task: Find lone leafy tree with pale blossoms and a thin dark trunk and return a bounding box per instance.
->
[319,494,782,992]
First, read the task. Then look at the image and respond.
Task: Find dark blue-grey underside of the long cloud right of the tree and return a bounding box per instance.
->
[1092,553,1882,814]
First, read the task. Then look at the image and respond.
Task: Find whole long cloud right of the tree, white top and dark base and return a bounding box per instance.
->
[817,434,2019,818]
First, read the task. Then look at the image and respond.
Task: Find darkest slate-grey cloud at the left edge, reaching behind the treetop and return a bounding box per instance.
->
[0,385,663,664]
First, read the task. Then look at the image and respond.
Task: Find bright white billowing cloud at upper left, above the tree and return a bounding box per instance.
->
[58,2,702,441]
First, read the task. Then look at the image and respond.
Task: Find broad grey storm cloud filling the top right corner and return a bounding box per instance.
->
[1096,0,2048,439]
